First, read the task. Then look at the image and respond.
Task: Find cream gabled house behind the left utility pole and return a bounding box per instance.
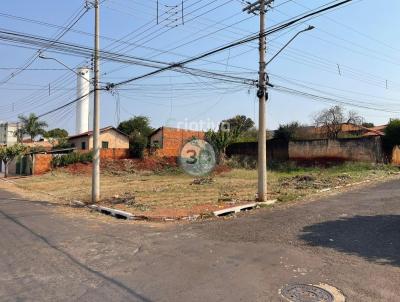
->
[68,126,129,150]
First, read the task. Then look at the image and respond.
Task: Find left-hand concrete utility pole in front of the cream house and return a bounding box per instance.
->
[92,0,100,202]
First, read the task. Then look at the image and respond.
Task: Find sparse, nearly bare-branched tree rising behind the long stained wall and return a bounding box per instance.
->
[314,106,363,139]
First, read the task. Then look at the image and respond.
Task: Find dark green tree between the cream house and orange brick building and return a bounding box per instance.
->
[118,116,154,158]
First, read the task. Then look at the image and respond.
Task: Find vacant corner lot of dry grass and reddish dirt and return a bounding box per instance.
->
[4,161,399,218]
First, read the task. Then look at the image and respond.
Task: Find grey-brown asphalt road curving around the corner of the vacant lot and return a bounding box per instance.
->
[0,181,400,302]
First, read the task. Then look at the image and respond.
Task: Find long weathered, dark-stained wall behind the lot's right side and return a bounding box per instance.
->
[289,137,385,163]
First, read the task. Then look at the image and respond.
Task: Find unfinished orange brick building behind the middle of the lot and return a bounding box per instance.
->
[149,127,205,156]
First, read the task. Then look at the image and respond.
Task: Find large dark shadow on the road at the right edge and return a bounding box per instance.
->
[300,215,400,266]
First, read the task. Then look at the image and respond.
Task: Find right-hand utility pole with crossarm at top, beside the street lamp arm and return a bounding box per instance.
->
[243,0,273,202]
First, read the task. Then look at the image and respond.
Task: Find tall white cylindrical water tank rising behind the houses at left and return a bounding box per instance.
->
[76,67,90,134]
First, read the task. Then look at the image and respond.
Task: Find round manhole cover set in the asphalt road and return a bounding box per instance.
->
[281,284,335,302]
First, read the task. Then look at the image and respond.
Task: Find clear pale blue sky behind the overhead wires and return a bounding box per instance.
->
[0,0,400,133]
